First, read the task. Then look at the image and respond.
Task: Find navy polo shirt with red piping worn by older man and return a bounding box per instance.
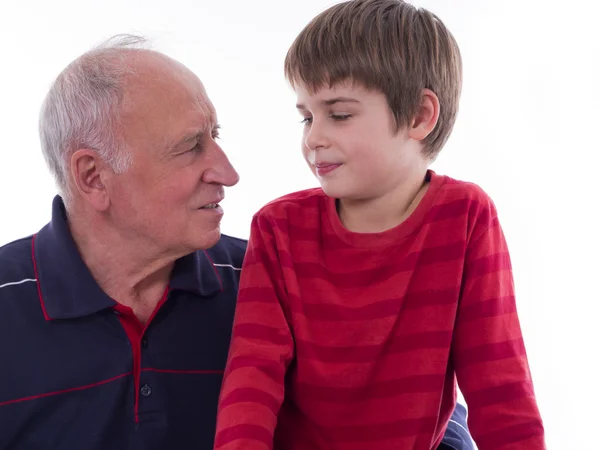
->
[0,197,246,450]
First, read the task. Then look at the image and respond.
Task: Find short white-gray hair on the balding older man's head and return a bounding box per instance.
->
[39,34,147,204]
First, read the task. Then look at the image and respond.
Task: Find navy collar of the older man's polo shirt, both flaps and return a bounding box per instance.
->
[32,195,222,320]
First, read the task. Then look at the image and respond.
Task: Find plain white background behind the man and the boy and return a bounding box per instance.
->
[0,0,600,450]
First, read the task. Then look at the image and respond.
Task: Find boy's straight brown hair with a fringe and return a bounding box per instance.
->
[285,0,462,160]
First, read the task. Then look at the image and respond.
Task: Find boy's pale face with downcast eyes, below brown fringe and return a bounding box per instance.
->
[296,82,428,200]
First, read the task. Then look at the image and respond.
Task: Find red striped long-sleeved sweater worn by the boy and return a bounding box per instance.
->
[215,172,545,450]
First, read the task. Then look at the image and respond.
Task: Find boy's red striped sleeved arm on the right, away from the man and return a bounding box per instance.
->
[452,205,546,450]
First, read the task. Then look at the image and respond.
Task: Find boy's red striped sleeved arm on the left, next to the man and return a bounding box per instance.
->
[214,215,294,450]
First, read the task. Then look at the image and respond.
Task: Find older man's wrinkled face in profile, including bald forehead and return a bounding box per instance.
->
[108,56,239,254]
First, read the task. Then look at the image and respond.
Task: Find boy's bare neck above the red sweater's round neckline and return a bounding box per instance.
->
[337,171,429,233]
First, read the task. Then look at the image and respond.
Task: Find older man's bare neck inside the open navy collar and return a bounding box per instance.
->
[68,209,183,323]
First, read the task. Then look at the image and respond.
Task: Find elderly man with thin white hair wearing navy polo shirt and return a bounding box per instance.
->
[0,36,468,450]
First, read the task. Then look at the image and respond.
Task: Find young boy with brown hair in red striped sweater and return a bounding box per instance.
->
[215,0,545,450]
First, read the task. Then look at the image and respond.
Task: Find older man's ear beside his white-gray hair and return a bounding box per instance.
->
[70,149,110,211]
